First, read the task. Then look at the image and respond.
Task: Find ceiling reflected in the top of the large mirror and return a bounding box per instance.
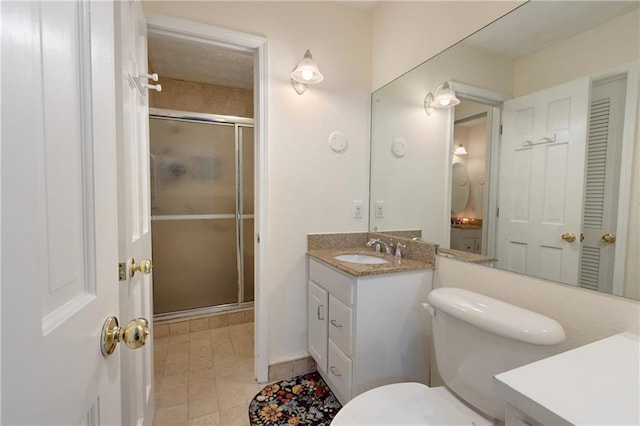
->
[464,0,640,58]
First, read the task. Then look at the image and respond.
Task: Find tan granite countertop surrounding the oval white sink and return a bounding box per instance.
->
[307,247,435,277]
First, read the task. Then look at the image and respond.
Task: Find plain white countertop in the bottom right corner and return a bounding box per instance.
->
[494,333,640,425]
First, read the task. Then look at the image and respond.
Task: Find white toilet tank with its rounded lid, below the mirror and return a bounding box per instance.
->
[428,287,565,420]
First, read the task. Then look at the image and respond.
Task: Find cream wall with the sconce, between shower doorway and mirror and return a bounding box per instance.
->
[144,1,371,362]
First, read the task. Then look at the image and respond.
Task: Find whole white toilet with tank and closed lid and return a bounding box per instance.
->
[331,288,565,426]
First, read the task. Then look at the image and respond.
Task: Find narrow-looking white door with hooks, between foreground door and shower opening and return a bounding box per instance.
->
[116,1,154,425]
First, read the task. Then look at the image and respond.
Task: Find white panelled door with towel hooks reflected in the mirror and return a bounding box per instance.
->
[496,78,590,285]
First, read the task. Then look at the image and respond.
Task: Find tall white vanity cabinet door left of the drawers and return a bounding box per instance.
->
[307,281,329,371]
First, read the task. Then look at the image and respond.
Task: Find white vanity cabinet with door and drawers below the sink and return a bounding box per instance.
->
[307,255,433,405]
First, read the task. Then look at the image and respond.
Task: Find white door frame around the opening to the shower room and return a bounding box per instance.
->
[146,14,269,383]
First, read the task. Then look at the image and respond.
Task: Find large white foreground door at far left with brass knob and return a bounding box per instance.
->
[2,0,126,425]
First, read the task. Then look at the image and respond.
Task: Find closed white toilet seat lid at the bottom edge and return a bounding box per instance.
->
[331,383,493,426]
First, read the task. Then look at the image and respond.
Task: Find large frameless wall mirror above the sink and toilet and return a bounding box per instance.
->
[369,1,640,300]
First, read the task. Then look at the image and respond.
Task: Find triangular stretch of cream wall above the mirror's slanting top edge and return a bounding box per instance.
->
[372,1,523,90]
